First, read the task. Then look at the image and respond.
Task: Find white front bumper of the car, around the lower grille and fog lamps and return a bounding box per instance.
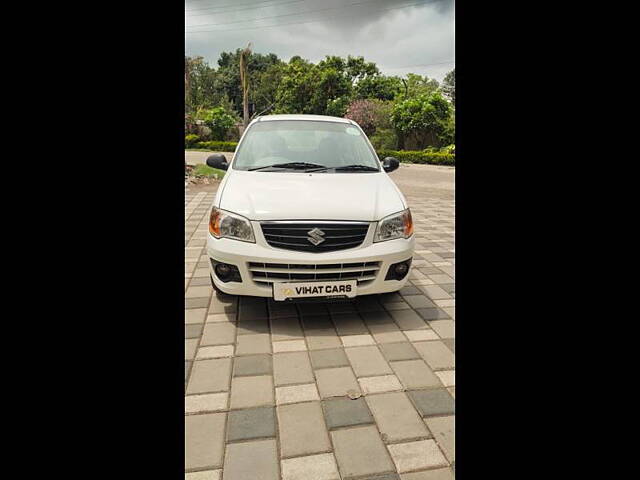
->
[207,222,415,297]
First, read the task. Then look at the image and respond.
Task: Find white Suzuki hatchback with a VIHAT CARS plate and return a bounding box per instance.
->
[207,115,414,300]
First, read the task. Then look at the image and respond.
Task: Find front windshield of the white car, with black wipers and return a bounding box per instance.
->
[233,120,380,172]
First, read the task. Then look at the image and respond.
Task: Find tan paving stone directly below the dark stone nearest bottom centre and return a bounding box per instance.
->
[331,425,395,478]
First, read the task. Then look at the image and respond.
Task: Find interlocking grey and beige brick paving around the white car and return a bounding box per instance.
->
[184,185,455,480]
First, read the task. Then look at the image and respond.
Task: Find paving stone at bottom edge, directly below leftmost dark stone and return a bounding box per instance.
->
[222,439,280,480]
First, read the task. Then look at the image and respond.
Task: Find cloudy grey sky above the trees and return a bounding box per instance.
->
[185,0,455,81]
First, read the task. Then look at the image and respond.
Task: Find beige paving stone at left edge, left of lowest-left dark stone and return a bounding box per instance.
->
[184,413,226,470]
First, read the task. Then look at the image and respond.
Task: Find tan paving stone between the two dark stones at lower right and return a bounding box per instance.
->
[366,392,431,442]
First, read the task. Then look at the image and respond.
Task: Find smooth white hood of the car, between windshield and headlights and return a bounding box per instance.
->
[218,170,406,222]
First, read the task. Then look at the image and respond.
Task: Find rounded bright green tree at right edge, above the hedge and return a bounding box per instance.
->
[391,91,451,149]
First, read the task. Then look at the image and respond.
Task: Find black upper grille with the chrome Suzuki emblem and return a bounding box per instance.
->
[260,222,369,253]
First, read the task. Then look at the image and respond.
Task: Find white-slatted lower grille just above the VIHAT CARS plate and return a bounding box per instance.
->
[249,262,380,285]
